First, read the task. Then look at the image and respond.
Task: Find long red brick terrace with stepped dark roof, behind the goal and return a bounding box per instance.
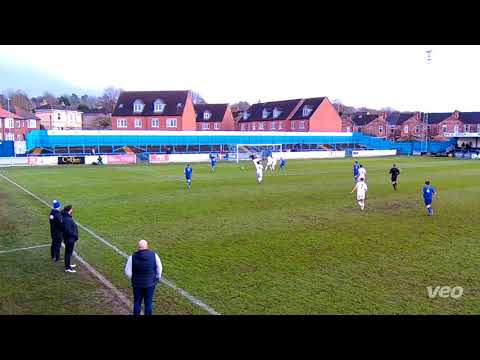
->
[237,97,342,132]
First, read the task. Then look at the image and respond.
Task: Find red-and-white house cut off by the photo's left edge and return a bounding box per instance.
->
[0,107,40,141]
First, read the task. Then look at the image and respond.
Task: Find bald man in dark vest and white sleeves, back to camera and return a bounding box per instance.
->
[125,240,162,315]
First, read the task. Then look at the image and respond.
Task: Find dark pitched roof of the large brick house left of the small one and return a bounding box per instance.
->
[112,90,189,116]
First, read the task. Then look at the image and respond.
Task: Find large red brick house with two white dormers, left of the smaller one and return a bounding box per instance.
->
[112,91,197,131]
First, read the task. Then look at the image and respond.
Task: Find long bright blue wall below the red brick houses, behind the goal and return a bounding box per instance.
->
[27,130,456,155]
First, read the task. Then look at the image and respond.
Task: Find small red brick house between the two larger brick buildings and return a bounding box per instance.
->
[194,104,235,131]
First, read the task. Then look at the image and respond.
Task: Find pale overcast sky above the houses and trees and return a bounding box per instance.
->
[0,45,480,112]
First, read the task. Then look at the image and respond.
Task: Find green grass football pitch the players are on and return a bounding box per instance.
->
[0,157,480,314]
